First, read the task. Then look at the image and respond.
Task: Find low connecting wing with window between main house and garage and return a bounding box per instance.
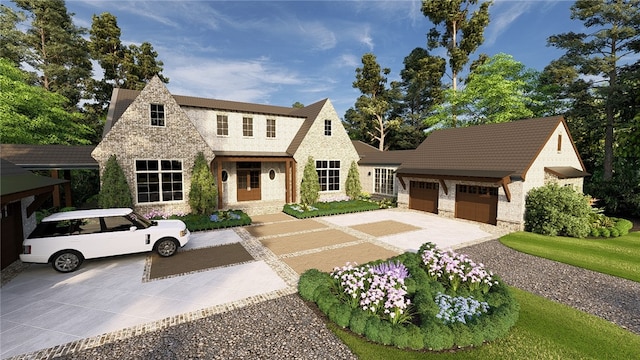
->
[353,140,414,198]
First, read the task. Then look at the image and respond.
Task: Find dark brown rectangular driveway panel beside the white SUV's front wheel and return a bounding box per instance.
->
[149,243,255,279]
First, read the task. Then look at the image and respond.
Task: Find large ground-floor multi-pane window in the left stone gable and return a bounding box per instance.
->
[136,160,183,203]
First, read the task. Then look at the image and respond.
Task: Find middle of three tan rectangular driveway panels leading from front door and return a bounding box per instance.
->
[260,229,359,255]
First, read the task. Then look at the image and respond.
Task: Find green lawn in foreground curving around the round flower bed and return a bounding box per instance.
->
[329,288,640,360]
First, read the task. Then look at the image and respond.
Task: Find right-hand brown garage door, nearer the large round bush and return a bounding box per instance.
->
[456,185,498,225]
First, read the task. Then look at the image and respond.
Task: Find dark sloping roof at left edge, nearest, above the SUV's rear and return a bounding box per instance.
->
[0,159,68,201]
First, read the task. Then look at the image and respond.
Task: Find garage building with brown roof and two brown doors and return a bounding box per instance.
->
[396,116,589,230]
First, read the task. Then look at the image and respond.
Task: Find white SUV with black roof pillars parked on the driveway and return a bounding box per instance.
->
[20,208,190,273]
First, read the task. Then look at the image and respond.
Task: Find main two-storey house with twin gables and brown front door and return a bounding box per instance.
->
[92,77,358,214]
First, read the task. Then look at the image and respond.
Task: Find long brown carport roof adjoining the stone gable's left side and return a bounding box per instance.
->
[0,144,98,170]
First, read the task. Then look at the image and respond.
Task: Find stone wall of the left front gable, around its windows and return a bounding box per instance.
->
[91,78,214,213]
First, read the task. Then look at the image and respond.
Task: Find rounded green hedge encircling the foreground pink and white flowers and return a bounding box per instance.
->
[298,248,519,351]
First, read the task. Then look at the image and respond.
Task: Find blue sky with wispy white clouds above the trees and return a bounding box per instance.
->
[62,0,582,117]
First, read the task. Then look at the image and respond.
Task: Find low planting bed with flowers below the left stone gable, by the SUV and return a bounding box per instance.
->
[144,210,251,231]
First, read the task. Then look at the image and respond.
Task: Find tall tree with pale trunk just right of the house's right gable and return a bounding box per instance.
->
[353,53,391,150]
